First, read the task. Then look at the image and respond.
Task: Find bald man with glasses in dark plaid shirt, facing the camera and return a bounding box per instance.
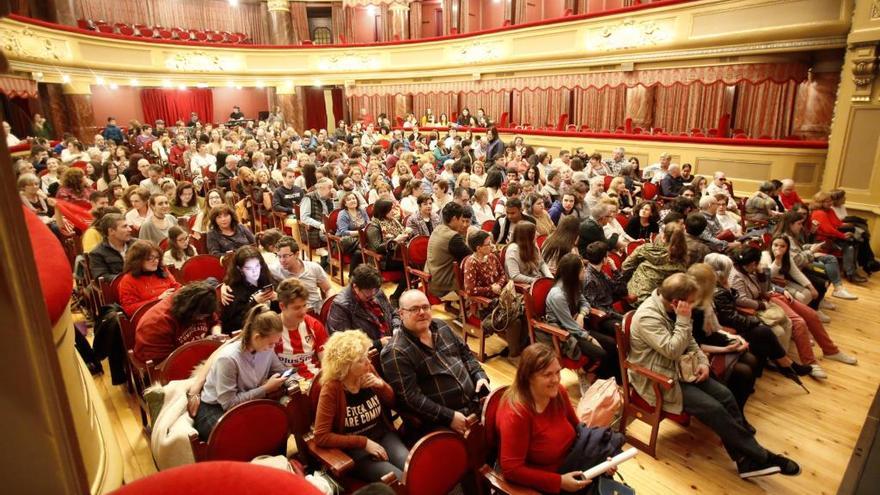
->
[381,290,489,433]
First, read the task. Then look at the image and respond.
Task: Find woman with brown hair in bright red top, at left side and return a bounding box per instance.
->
[119,241,180,316]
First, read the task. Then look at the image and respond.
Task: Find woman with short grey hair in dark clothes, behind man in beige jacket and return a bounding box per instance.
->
[703,253,811,383]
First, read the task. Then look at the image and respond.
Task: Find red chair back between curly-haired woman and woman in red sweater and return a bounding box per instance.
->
[403,431,468,495]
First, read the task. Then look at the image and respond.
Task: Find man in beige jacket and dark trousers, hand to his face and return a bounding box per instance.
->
[629,273,800,479]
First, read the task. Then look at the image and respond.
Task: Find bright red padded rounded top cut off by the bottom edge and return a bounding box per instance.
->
[111,461,321,495]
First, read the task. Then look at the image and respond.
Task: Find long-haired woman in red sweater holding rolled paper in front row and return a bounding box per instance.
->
[497,343,613,493]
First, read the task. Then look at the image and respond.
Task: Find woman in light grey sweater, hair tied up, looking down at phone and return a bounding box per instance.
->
[193,304,287,441]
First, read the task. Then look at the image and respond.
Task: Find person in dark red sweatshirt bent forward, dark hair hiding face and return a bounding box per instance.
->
[134,282,220,363]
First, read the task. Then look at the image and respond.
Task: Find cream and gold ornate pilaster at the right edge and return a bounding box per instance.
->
[820,1,880,250]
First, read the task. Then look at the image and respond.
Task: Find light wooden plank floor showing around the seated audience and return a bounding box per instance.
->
[96,275,880,495]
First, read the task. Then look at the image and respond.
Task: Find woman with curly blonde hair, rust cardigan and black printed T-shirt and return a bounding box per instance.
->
[315,330,409,482]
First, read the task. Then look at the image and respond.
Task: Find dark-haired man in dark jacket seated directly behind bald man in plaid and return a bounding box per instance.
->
[325,264,400,351]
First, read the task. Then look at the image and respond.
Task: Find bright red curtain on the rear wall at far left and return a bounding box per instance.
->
[141,88,214,127]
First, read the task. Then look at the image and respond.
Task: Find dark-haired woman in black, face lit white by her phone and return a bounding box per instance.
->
[220,246,276,334]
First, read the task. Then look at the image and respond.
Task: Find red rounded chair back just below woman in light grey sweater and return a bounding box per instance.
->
[205,399,289,462]
